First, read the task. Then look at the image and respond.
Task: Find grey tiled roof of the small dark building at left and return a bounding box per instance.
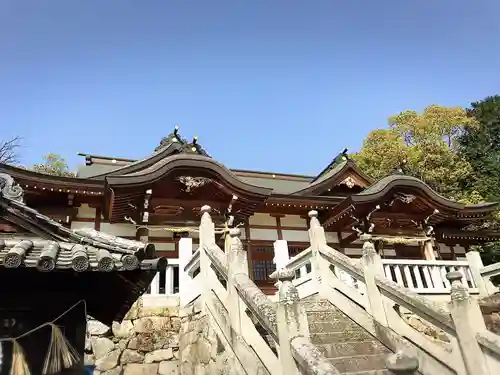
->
[0,173,166,272]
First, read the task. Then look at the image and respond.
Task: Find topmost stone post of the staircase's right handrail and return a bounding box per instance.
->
[309,210,328,294]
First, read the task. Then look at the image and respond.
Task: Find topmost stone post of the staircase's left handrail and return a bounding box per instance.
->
[199,206,215,312]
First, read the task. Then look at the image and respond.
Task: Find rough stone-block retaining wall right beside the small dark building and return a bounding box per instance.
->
[85,296,181,375]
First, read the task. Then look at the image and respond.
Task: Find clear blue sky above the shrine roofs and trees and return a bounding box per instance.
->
[0,0,500,174]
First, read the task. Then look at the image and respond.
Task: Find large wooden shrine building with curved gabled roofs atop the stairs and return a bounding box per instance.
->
[0,128,499,293]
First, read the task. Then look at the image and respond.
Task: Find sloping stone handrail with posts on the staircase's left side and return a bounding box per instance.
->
[195,206,338,375]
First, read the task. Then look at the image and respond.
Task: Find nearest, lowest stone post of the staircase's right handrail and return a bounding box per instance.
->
[446,271,489,375]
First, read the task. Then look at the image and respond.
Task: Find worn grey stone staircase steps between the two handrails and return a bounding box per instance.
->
[302,298,391,375]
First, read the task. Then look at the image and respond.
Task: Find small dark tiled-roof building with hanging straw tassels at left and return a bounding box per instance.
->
[0,173,167,375]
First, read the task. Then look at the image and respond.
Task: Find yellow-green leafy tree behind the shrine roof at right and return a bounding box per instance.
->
[352,105,477,200]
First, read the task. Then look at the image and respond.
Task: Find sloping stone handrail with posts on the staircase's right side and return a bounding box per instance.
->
[298,211,500,375]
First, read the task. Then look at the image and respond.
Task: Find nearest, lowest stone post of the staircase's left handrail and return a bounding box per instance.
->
[276,268,309,375]
